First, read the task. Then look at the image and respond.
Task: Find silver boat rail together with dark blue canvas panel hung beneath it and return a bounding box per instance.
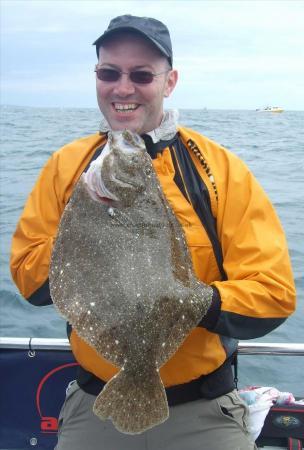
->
[0,337,304,450]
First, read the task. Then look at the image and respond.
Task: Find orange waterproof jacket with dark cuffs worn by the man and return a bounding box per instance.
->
[11,127,295,387]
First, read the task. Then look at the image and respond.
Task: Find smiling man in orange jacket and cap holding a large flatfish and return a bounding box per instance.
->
[11,15,295,450]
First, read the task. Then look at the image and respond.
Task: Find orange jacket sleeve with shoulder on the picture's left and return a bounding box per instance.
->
[10,133,106,306]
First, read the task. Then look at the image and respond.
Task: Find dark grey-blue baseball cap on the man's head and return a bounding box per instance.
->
[93,14,173,67]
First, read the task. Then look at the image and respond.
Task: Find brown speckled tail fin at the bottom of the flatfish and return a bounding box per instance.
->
[93,369,169,434]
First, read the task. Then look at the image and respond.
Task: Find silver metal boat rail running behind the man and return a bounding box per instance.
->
[0,337,304,356]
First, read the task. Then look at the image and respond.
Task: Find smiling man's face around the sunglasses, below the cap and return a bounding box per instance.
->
[96,34,177,134]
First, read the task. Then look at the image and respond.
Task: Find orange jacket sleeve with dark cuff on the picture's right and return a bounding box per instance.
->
[200,147,295,339]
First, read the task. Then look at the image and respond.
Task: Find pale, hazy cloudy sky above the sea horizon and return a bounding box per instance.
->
[0,0,304,110]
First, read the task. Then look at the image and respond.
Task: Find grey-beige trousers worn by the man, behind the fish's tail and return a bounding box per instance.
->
[55,382,257,450]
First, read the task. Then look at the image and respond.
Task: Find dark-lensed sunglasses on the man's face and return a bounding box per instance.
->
[95,66,170,84]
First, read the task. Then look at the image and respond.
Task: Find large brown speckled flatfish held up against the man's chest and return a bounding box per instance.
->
[50,130,212,434]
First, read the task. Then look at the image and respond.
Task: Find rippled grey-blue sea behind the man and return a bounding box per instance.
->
[0,106,304,398]
